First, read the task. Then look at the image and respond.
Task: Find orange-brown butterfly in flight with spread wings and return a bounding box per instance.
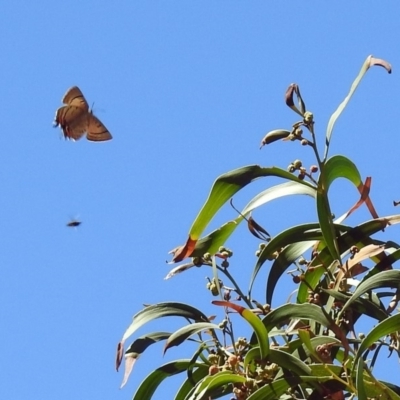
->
[54,86,112,142]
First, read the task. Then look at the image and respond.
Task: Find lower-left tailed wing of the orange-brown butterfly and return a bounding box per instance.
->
[55,106,91,140]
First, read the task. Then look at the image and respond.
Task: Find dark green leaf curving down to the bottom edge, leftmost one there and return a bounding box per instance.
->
[133,360,208,400]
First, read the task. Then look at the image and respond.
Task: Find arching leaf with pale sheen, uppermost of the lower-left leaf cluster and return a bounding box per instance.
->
[121,302,208,342]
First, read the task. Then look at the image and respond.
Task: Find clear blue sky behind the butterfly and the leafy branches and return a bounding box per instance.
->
[0,0,400,400]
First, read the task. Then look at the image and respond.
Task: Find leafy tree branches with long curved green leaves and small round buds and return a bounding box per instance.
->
[116,56,400,400]
